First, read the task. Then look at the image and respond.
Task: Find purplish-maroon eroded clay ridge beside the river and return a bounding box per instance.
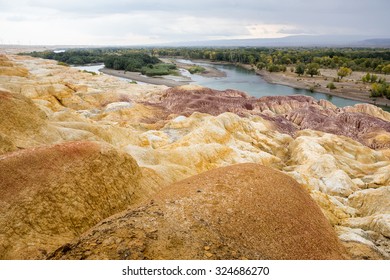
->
[148,86,390,149]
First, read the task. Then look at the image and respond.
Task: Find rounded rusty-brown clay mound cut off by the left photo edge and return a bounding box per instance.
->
[0,142,140,259]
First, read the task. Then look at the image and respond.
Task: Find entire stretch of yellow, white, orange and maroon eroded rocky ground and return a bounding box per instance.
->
[0,55,390,259]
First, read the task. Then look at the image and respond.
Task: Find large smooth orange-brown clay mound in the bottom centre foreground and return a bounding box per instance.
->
[50,164,346,259]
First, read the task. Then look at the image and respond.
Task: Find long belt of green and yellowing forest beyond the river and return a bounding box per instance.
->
[24,47,390,98]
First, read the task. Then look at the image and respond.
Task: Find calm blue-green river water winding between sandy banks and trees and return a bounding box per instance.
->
[75,62,374,107]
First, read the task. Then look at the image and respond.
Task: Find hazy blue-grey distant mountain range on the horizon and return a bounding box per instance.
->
[163,35,390,48]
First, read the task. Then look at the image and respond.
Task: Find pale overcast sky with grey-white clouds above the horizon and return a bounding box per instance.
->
[0,0,390,45]
